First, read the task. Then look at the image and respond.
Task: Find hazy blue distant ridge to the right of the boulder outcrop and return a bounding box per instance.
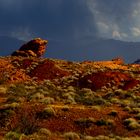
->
[46,37,140,63]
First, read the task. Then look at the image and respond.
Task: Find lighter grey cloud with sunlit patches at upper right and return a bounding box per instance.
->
[88,0,140,41]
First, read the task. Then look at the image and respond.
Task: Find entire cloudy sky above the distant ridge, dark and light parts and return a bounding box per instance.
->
[0,0,140,41]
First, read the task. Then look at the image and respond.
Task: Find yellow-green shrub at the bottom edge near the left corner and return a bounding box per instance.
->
[4,131,21,140]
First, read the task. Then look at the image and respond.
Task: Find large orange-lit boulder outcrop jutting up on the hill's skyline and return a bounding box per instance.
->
[11,38,48,57]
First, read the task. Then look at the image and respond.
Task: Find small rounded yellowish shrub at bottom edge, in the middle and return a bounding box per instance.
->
[63,132,80,140]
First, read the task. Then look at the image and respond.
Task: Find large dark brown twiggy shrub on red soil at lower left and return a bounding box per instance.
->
[10,104,40,135]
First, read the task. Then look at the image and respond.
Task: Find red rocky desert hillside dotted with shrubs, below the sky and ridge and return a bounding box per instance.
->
[0,38,140,140]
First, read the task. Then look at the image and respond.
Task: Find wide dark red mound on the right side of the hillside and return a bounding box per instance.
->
[79,71,140,90]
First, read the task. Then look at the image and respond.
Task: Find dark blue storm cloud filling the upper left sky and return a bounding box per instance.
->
[0,0,97,39]
